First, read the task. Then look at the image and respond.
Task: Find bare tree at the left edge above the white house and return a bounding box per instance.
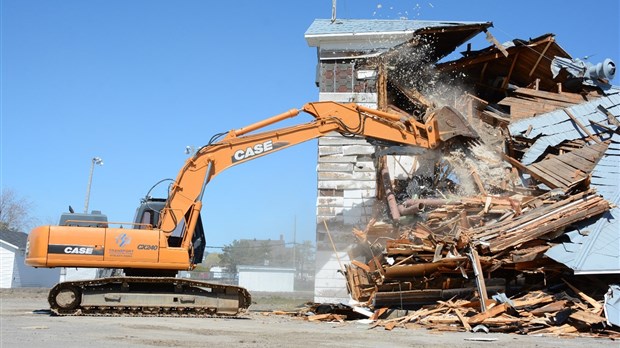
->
[0,188,36,232]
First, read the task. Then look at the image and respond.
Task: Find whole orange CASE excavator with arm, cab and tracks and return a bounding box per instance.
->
[26,102,475,316]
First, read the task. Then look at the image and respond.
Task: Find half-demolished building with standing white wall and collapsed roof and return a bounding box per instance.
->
[305,19,620,331]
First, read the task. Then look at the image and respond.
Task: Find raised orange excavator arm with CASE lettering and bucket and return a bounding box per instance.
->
[159,102,472,254]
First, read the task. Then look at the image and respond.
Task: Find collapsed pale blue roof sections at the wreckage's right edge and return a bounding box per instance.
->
[509,87,620,274]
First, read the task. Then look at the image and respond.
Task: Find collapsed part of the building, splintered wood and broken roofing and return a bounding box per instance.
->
[343,30,620,338]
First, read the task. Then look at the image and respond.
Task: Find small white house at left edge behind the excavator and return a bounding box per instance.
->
[0,228,60,288]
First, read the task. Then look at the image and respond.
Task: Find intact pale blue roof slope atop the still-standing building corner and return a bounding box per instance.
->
[304,19,488,37]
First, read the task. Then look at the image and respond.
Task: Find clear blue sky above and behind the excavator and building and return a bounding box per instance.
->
[0,0,620,246]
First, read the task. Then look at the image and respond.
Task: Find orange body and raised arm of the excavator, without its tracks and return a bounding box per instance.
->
[21,102,474,274]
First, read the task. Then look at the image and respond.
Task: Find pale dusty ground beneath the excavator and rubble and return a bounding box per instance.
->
[0,289,619,348]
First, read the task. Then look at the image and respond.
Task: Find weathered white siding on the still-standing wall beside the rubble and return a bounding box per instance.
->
[314,93,377,303]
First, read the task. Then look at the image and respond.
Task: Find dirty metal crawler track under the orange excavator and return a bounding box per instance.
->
[48,277,252,318]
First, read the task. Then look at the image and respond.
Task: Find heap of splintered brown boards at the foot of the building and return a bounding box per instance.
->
[340,185,618,337]
